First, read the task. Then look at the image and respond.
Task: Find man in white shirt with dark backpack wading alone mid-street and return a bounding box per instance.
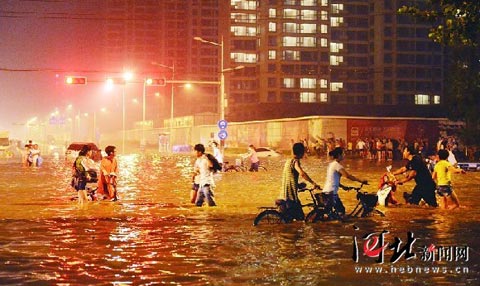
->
[193,144,217,207]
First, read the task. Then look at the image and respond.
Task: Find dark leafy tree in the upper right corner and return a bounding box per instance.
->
[398,0,480,145]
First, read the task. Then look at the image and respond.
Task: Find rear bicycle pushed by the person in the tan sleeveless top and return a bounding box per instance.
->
[253,183,321,226]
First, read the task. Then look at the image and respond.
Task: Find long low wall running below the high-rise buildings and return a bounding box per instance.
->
[101,116,444,153]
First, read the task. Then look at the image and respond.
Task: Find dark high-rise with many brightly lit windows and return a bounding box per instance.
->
[222,0,443,121]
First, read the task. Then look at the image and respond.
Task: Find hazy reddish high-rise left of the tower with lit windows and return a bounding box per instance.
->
[101,0,225,126]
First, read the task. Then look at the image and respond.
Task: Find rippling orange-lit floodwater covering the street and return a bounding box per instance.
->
[0,154,480,285]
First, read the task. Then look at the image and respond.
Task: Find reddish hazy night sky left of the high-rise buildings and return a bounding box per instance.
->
[0,0,104,137]
